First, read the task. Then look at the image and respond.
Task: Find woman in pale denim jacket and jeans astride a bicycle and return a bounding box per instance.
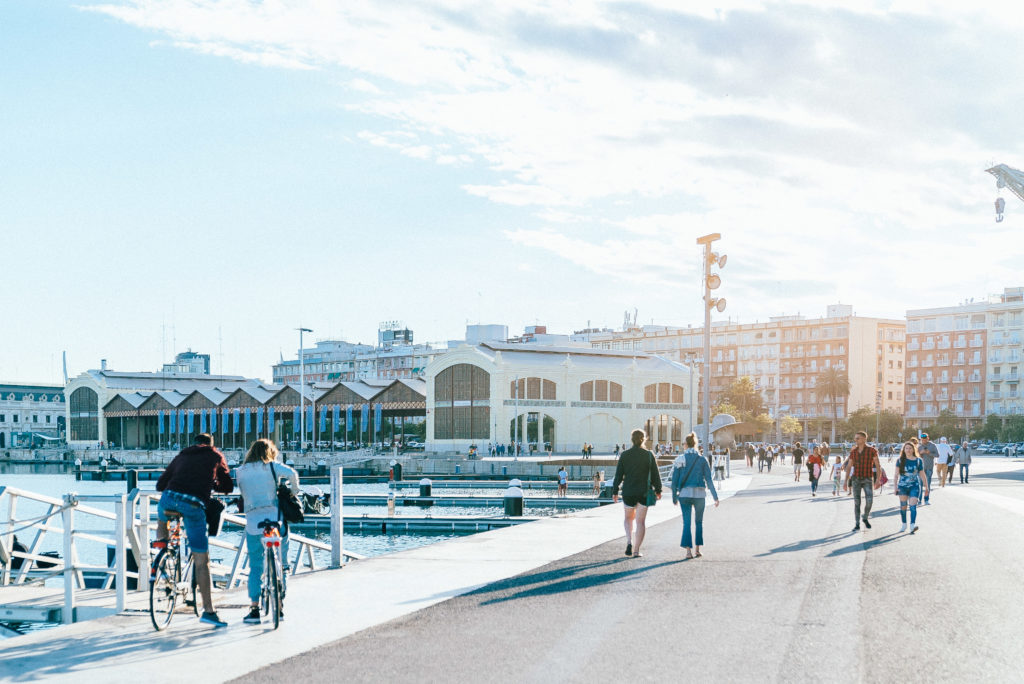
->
[234,439,299,625]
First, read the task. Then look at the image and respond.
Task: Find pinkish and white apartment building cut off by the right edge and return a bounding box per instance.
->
[905,288,1024,429]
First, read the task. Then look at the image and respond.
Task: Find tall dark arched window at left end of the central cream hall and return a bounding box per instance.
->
[434,364,490,439]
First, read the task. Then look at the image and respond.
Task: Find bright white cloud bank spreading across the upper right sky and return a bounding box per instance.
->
[83,0,1024,321]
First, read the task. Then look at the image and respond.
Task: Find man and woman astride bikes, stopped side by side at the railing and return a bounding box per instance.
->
[154,434,299,627]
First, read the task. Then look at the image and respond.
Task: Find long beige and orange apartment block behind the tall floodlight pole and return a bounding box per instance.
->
[572,304,906,438]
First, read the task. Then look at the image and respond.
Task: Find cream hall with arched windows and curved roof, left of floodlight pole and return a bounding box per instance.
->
[426,342,693,453]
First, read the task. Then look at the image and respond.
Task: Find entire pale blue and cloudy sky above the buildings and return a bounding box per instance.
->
[0,0,1024,382]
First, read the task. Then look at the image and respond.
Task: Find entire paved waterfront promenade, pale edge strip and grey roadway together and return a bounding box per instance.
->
[0,459,1024,682]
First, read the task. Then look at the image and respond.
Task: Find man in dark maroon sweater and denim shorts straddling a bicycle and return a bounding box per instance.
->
[155,433,234,627]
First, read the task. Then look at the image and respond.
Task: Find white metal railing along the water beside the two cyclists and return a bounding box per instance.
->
[0,467,364,624]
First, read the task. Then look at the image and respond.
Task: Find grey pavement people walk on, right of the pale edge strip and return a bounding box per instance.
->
[235,462,1024,682]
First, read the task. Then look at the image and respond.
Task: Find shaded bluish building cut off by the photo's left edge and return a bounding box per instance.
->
[0,383,67,448]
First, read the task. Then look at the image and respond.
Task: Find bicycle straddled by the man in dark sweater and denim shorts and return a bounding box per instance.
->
[150,511,199,632]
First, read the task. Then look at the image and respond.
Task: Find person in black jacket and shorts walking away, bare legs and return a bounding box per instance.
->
[611,430,662,558]
